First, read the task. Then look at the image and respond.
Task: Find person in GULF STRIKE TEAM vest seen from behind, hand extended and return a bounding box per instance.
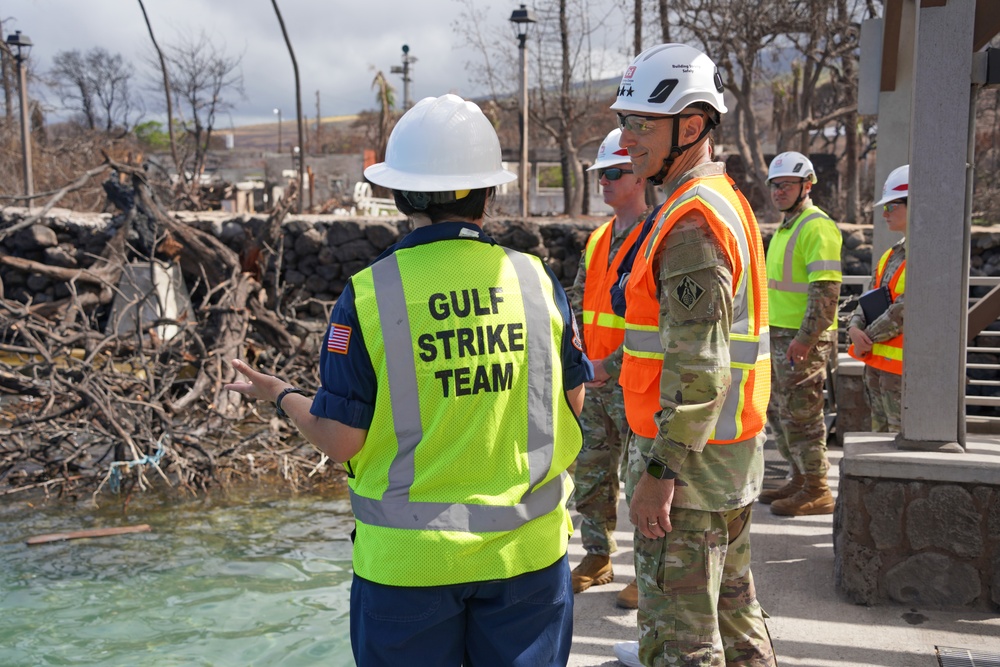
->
[223,95,593,667]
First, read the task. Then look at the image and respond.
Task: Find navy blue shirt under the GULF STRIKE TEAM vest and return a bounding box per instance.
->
[310,222,594,429]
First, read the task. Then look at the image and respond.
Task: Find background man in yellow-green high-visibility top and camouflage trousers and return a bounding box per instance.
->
[760,151,843,516]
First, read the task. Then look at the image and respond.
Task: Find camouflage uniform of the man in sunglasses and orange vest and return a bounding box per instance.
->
[567,213,646,556]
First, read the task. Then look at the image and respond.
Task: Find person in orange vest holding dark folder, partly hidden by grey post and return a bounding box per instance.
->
[847,165,910,433]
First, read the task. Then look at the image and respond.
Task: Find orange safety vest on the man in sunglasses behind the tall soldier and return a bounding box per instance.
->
[583,218,642,359]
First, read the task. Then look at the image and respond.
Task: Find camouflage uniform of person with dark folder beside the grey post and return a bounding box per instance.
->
[847,239,906,433]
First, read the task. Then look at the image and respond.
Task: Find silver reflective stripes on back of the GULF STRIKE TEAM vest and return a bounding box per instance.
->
[351,249,565,533]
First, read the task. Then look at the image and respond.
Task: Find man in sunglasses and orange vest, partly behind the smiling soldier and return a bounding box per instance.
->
[568,129,649,609]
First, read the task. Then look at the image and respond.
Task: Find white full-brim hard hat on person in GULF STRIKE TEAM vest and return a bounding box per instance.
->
[365,95,517,192]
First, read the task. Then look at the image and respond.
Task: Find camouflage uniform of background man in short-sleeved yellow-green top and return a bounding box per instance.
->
[768,197,840,476]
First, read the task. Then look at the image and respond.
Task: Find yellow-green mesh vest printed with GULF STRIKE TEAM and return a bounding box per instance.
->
[349,238,582,586]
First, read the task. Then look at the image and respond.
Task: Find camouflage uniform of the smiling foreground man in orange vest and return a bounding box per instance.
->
[608,163,775,667]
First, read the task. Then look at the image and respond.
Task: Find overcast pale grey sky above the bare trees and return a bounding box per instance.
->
[0,0,631,127]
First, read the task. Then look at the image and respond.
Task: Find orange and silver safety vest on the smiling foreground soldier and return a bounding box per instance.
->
[619,174,771,445]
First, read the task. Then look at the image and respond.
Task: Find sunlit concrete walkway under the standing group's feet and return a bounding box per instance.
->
[569,443,1000,667]
